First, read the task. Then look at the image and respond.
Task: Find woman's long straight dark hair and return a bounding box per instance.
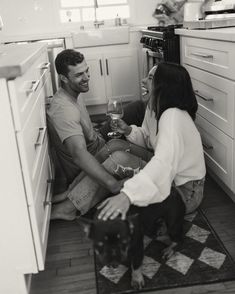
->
[150,62,198,122]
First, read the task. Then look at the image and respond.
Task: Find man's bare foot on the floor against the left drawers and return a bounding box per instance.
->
[51,199,77,221]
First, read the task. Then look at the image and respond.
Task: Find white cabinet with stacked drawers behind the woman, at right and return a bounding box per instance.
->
[178,29,235,200]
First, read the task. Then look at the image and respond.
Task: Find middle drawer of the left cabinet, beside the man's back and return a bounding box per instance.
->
[17,84,47,203]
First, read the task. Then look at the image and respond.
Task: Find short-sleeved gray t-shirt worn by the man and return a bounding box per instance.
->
[47,88,104,181]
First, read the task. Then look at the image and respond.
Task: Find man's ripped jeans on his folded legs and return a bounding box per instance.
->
[67,139,152,215]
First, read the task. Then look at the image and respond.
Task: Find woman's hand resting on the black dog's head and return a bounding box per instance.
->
[98,192,131,220]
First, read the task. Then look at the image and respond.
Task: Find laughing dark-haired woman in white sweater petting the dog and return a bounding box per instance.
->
[99,62,206,220]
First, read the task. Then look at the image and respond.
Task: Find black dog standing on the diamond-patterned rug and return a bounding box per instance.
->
[79,189,185,289]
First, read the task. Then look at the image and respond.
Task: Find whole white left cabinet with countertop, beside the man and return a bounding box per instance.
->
[0,44,53,294]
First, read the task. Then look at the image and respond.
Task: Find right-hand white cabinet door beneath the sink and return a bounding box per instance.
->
[104,49,139,101]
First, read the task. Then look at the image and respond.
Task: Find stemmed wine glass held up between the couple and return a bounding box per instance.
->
[107,98,123,139]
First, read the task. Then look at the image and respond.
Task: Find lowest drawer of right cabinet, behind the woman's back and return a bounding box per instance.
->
[196,115,233,190]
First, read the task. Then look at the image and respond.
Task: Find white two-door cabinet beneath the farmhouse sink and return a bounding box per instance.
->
[79,48,139,106]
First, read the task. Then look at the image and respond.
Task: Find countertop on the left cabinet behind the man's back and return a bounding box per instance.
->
[0,43,46,79]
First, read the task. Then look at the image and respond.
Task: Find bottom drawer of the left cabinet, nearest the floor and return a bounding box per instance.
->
[30,149,52,270]
